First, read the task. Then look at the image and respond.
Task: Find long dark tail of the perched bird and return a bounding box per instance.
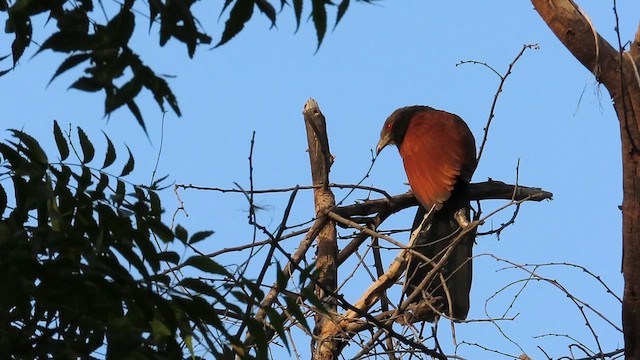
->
[407,190,476,321]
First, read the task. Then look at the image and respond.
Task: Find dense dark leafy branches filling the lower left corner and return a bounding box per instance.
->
[0,123,282,359]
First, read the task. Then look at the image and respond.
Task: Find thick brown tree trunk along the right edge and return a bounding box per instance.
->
[531,0,640,359]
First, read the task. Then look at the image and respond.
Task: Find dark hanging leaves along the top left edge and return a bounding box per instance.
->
[0,0,360,129]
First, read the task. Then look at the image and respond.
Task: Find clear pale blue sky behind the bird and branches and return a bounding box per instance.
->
[0,0,640,359]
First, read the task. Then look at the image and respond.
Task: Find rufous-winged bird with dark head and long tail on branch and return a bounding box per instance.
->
[376,105,477,321]
